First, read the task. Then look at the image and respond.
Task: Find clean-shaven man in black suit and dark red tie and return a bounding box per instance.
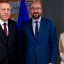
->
[0,2,19,64]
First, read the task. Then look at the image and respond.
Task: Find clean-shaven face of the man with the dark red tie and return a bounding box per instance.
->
[0,3,11,21]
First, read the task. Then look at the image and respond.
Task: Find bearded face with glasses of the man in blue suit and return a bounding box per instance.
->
[30,2,42,19]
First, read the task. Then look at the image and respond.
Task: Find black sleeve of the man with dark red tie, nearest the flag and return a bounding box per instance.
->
[14,23,20,64]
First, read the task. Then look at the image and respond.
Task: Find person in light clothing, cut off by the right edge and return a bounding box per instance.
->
[59,32,64,64]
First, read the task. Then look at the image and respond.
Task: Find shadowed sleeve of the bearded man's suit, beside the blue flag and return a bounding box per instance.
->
[19,26,26,64]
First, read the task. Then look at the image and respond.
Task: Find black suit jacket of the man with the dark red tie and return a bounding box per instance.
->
[0,20,19,64]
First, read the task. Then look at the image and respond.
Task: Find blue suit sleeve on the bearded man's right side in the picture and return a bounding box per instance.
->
[49,22,58,64]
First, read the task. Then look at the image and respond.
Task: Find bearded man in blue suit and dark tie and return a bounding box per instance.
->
[22,2,58,64]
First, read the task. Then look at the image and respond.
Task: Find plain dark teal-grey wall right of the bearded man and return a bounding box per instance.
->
[44,0,64,35]
